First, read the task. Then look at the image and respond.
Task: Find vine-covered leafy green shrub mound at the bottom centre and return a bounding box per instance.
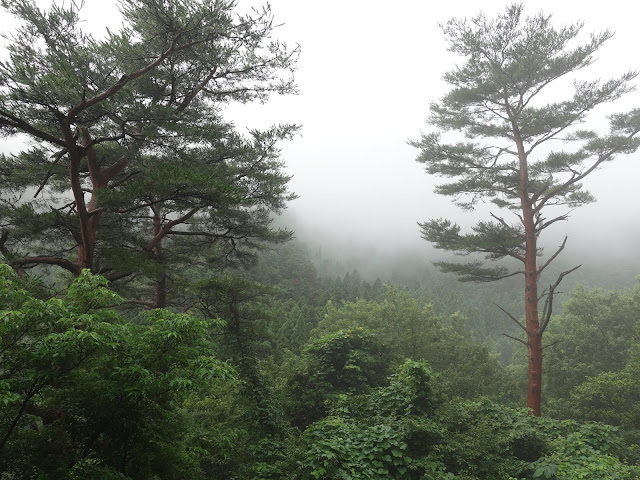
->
[299,360,443,480]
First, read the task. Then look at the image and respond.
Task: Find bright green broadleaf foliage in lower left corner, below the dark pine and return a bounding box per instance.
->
[0,265,235,479]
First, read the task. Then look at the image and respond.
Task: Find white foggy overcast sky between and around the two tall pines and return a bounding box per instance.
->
[1,0,640,270]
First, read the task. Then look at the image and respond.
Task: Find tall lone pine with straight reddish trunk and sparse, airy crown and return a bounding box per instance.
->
[411,4,640,415]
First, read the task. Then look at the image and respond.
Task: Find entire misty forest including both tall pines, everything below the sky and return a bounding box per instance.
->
[0,0,640,480]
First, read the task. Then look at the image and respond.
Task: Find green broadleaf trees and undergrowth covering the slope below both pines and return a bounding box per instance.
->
[0,243,640,479]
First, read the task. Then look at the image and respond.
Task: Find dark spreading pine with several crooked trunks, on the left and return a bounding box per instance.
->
[0,0,298,307]
